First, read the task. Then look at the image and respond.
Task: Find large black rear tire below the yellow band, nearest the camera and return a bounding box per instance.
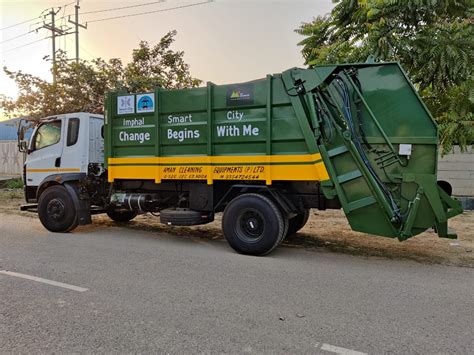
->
[222,193,287,255]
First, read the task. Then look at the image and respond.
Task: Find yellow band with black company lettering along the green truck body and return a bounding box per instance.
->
[108,154,329,185]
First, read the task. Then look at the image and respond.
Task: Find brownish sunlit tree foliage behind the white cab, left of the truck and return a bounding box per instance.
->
[0,31,201,118]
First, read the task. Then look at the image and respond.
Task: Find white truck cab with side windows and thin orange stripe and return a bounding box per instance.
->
[23,112,104,202]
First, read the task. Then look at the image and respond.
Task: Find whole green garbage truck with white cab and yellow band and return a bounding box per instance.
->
[19,63,462,255]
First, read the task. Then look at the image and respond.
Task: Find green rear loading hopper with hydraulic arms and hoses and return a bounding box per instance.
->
[282,63,462,240]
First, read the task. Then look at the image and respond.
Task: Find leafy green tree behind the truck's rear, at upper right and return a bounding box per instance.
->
[295,0,474,152]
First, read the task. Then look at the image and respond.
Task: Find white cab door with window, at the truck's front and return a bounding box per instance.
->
[25,119,64,190]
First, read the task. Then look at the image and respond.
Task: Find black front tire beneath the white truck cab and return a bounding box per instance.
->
[38,185,79,233]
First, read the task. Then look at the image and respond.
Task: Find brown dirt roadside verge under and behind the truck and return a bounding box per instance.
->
[0,189,474,267]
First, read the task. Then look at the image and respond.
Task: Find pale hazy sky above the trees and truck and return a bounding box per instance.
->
[0,0,333,118]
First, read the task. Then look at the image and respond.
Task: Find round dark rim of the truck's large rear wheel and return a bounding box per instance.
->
[235,208,265,243]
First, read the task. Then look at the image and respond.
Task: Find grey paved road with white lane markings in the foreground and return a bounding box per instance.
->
[0,215,474,354]
